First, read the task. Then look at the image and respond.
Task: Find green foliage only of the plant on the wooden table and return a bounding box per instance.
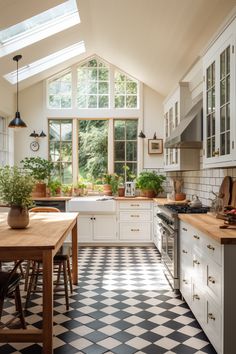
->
[0,166,35,207]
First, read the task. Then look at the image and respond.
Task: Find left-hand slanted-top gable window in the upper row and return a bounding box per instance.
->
[48,72,72,108]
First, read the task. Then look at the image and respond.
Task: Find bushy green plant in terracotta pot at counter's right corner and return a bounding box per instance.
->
[137,171,166,198]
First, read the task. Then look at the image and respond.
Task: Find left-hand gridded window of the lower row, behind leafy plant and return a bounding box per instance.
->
[49,119,73,184]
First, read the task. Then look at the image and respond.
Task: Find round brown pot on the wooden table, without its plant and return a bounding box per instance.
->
[7,206,29,229]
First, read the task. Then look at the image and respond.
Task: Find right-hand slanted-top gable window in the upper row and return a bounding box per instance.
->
[114,70,138,108]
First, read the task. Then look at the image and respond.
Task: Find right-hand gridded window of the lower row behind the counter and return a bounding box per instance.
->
[114,119,138,180]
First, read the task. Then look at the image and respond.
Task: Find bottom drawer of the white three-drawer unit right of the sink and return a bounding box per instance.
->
[120,222,151,242]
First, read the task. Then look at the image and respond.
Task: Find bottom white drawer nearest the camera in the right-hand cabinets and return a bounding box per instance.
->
[204,297,222,353]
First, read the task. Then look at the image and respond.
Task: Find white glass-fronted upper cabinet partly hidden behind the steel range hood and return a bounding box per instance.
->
[164,82,199,171]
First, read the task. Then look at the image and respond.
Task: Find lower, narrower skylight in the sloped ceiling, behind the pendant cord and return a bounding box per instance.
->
[4,41,86,84]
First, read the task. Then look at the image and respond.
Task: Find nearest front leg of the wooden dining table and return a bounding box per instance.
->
[43,250,53,354]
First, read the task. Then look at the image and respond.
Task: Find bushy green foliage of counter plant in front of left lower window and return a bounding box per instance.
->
[21,156,53,182]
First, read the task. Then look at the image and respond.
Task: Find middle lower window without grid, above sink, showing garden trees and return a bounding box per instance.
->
[78,120,108,179]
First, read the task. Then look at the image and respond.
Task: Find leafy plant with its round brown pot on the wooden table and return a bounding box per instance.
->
[0,166,35,229]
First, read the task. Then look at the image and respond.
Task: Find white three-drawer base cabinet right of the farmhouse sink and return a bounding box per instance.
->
[118,200,153,243]
